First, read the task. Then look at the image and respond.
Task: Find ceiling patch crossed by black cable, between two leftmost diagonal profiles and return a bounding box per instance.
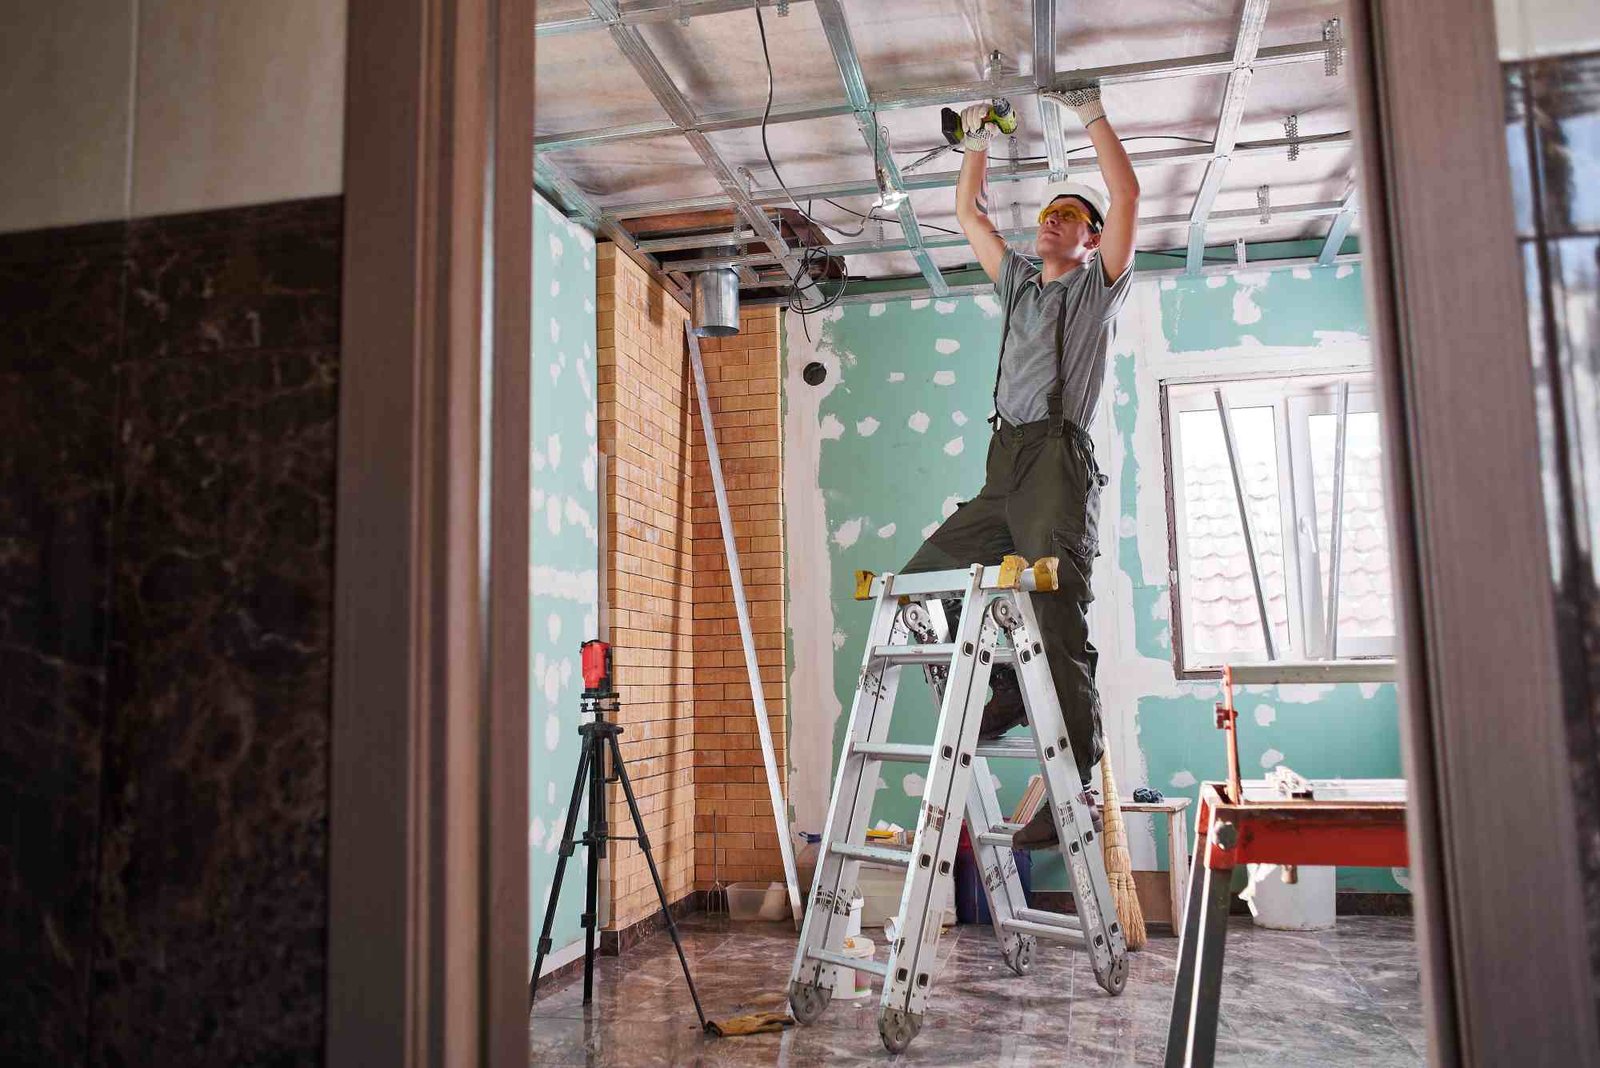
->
[638,3,845,115]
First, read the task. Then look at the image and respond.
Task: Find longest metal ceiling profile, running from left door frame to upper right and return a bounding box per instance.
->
[533,38,1328,152]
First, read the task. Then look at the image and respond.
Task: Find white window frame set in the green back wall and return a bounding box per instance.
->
[1160,371,1395,678]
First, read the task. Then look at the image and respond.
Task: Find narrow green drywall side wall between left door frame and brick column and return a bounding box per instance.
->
[528,187,600,954]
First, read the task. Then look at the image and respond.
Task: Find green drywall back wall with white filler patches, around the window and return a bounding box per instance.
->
[784,267,1400,891]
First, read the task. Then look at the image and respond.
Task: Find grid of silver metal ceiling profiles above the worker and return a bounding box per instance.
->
[534,0,1358,304]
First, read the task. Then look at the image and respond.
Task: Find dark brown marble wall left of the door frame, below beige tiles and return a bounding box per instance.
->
[0,198,341,1065]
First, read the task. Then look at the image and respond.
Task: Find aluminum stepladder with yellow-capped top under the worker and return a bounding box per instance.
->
[789,556,1128,1054]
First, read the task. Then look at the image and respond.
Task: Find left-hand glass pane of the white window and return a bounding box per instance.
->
[1178,408,1290,664]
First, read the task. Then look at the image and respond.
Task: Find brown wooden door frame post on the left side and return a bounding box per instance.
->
[326,0,534,1066]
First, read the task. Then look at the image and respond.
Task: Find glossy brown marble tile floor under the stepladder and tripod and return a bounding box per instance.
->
[530,916,1426,1068]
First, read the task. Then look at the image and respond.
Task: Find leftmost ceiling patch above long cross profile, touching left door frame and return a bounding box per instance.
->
[533,29,667,136]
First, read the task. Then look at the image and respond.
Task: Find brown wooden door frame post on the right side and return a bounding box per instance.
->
[1349,0,1600,1065]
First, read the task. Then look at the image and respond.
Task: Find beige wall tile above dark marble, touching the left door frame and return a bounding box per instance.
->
[131,0,346,216]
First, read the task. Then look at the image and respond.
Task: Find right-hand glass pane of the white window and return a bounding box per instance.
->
[1310,412,1395,639]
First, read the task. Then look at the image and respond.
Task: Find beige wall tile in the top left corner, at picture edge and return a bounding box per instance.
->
[0,0,133,232]
